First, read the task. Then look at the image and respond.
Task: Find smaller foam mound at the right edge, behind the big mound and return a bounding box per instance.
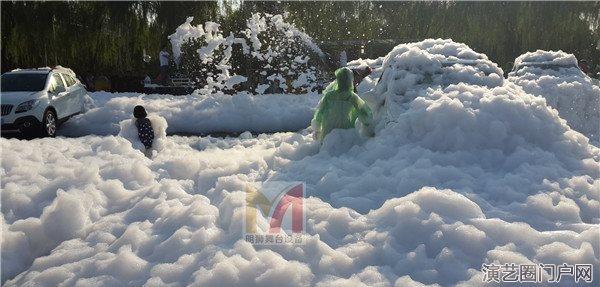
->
[508,50,600,145]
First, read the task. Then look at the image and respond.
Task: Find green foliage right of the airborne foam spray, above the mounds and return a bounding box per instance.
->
[284,1,600,74]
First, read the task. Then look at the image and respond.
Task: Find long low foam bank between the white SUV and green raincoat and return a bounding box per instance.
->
[59,92,320,137]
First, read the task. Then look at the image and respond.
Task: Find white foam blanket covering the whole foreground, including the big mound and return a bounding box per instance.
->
[0,40,600,286]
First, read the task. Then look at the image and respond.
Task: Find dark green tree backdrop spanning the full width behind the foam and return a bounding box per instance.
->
[1,1,600,79]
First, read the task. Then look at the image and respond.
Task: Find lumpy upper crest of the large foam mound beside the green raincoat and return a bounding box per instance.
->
[364,39,504,125]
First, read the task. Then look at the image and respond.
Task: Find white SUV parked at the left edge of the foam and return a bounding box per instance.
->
[0,66,87,137]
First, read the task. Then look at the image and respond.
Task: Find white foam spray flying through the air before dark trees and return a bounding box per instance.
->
[172,13,322,93]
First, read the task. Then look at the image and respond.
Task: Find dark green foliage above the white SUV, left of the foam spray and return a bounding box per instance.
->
[1,1,217,75]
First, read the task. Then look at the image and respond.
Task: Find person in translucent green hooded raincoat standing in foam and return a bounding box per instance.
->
[313,68,373,141]
